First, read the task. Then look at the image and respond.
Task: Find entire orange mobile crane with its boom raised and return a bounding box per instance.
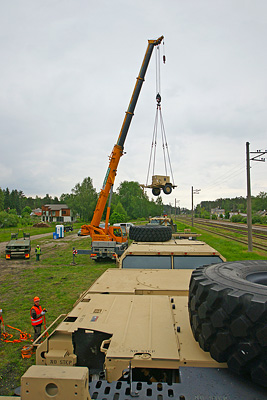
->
[77,36,164,260]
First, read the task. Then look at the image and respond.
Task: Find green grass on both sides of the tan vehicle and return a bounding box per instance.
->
[0,222,267,395]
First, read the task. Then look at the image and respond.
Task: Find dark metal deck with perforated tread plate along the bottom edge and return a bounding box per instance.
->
[89,367,267,400]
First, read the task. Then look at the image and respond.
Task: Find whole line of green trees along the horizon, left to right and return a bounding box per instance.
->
[0,181,267,226]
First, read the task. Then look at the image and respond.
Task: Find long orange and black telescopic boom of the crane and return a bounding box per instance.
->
[82,36,164,236]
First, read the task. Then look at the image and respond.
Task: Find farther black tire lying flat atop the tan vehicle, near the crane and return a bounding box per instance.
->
[129,225,172,242]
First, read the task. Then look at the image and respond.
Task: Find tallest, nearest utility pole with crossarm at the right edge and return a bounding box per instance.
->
[246,142,267,252]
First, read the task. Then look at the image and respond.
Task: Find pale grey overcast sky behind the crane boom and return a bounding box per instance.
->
[0,0,267,208]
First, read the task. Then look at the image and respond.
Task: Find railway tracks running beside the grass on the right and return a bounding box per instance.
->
[178,217,267,251]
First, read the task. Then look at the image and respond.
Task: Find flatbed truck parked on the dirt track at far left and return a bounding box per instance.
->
[6,232,31,260]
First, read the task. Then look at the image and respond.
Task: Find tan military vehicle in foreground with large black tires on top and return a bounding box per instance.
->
[13,226,267,400]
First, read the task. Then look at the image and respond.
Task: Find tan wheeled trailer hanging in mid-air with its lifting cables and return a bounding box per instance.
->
[140,46,177,196]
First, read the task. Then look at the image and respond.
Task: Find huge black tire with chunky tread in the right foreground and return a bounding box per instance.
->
[189,260,267,387]
